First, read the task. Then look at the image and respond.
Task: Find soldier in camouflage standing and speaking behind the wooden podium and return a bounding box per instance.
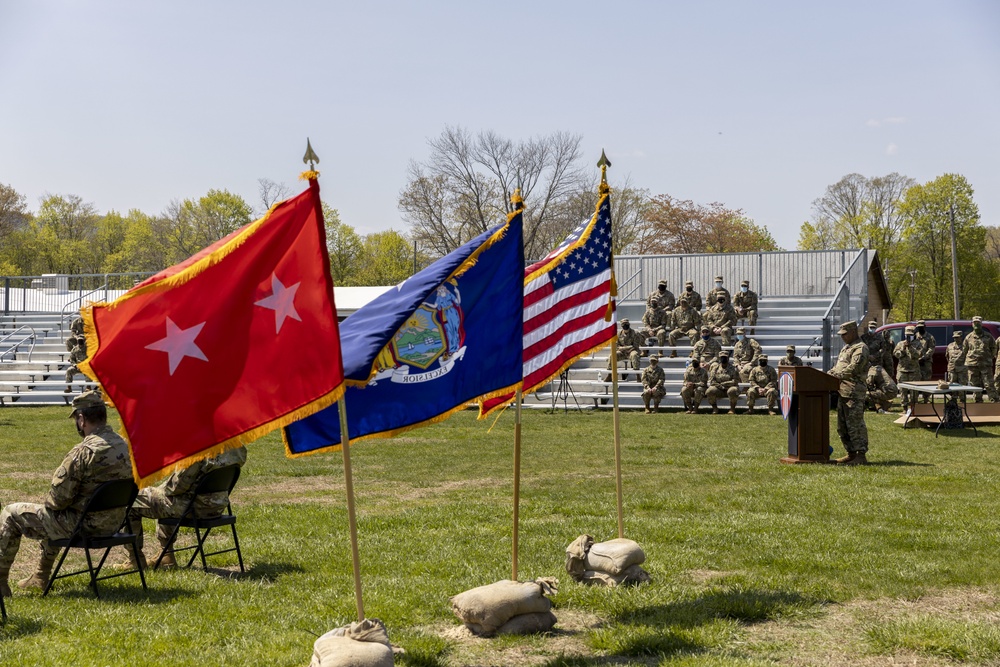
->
[830,321,869,465]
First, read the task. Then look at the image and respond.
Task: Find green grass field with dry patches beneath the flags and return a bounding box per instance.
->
[0,408,1000,667]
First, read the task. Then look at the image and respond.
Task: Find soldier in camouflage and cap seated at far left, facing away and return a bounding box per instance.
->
[0,391,132,597]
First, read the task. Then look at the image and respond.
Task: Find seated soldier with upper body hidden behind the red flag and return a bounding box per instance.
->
[119,447,247,569]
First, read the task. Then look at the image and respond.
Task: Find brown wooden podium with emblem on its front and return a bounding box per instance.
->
[778,366,840,463]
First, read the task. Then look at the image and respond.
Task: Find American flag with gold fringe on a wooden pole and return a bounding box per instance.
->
[480,194,615,417]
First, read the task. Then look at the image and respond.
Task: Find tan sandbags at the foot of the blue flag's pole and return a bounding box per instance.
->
[451,578,557,636]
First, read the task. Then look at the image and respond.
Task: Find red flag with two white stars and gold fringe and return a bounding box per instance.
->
[80,179,344,486]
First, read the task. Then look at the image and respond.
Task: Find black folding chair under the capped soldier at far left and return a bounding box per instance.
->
[42,479,149,597]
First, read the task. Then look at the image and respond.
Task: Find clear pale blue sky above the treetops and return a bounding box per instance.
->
[0,0,1000,248]
